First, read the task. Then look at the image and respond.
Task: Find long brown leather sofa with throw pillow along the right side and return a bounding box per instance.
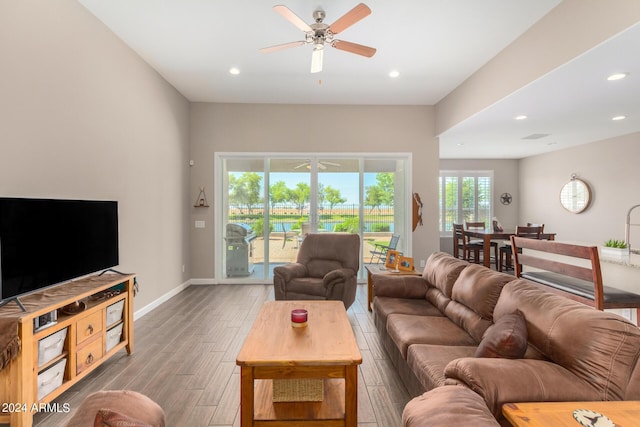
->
[372,252,640,427]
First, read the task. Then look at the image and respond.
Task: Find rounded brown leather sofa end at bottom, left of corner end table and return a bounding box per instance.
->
[402,386,500,427]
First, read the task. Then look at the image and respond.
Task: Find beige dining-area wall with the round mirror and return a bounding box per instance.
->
[519,133,640,248]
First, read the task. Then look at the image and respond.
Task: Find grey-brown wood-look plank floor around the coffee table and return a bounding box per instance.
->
[34,285,410,427]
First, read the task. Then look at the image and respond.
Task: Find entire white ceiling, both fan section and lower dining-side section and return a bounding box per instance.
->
[79,0,640,158]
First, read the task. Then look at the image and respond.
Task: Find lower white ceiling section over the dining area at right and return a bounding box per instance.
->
[440,25,640,159]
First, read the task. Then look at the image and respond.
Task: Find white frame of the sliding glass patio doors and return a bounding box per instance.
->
[213,152,413,284]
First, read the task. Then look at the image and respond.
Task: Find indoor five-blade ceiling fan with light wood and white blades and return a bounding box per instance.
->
[260,3,376,73]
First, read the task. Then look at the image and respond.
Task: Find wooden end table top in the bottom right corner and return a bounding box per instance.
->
[502,400,640,427]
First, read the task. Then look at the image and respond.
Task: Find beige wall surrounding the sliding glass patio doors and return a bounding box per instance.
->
[190,103,439,279]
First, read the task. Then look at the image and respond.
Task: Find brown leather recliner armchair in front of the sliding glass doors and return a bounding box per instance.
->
[273,233,360,309]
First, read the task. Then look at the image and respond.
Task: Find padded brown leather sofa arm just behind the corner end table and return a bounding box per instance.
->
[444,357,602,419]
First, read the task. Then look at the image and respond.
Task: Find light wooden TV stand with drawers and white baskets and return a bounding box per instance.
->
[0,274,135,427]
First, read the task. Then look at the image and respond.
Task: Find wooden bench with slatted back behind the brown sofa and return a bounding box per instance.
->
[511,236,640,322]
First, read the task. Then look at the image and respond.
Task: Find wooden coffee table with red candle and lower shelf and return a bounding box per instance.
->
[236,301,362,427]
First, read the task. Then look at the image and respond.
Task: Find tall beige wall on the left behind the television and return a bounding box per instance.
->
[0,0,192,310]
